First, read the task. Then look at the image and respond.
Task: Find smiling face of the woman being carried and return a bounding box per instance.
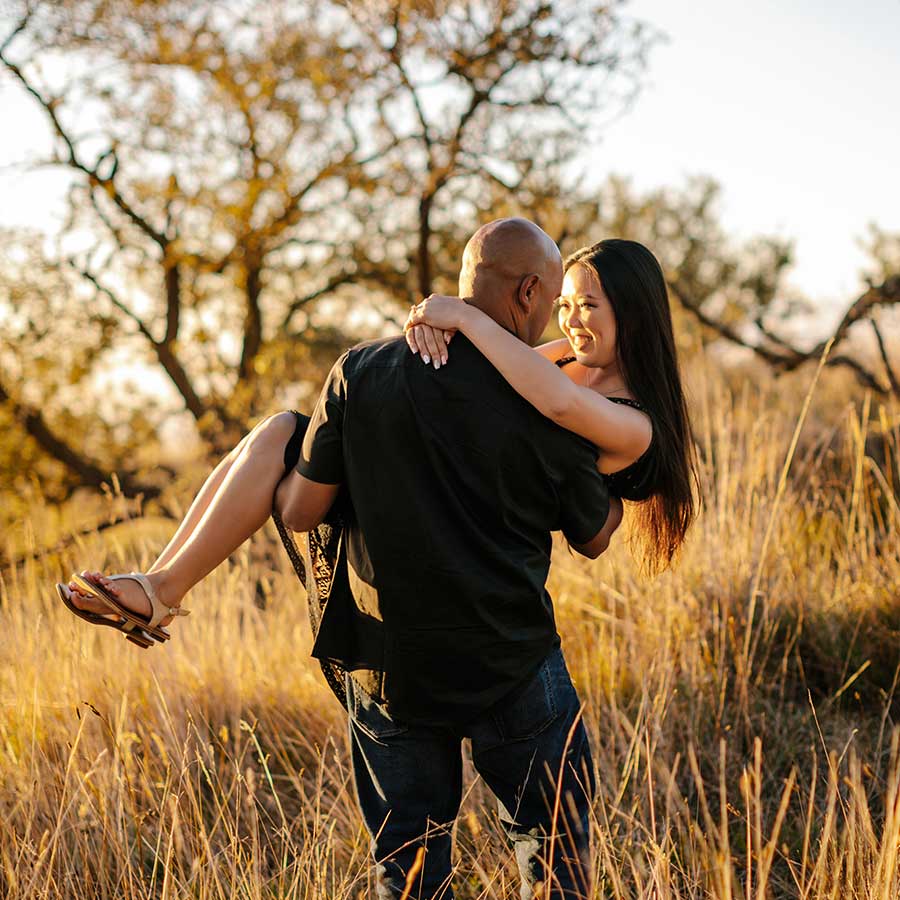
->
[558,264,616,368]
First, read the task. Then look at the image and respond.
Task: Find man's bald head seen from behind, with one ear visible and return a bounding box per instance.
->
[459,218,562,345]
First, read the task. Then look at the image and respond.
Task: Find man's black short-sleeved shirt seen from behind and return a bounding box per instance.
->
[297,334,609,724]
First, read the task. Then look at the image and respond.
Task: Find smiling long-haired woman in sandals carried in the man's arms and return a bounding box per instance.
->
[57,239,695,646]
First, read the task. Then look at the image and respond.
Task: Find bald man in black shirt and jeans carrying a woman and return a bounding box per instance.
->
[276,219,618,898]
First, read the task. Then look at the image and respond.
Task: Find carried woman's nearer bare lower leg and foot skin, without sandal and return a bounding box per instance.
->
[76,412,297,615]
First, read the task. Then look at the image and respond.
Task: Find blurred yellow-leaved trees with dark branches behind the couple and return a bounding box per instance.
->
[0,0,900,512]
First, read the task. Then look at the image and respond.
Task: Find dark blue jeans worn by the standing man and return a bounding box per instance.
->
[347,649,594,900]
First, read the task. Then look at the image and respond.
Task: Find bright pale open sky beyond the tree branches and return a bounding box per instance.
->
[0,0,900,332]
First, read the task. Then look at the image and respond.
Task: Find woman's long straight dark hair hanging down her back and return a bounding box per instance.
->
[564,238,697,572]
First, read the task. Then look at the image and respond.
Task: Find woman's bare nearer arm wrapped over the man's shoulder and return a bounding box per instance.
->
[407,296,652,465]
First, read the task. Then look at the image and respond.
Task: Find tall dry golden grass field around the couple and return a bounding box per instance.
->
[0,356,900,900]
